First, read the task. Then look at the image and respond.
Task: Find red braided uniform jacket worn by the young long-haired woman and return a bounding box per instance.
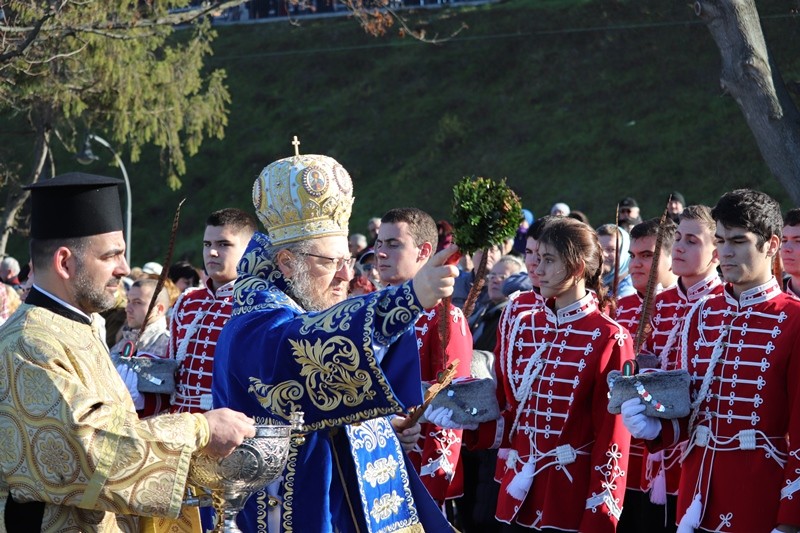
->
[465,293,633,533]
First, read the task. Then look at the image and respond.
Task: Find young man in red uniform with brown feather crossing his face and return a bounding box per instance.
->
[616,218,677,533]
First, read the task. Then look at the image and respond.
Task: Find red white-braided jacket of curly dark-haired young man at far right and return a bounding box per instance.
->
[652,278,800,533]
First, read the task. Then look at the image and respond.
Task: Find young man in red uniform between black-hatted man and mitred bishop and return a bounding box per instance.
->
[170,208,257,413]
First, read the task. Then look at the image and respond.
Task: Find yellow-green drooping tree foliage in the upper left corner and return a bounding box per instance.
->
[0,0,230,189]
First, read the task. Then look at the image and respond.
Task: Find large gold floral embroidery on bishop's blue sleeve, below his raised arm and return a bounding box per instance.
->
[289,336,375,411]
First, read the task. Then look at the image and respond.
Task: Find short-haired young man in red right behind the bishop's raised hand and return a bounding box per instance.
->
[375,207,472,505]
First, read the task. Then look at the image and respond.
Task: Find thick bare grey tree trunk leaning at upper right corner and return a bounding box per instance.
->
[694,0,800,205]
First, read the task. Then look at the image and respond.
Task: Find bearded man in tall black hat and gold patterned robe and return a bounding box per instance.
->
[0,173,255,533]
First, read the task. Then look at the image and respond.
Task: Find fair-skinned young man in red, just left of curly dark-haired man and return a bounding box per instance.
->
[623,205,722,533]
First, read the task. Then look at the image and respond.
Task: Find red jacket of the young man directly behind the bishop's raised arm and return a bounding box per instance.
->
[408,304,472,504]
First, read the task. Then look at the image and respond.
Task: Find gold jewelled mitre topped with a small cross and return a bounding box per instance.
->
[253,138,353,245]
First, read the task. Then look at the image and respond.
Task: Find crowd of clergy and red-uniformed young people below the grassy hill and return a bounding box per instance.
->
[0,149,800,533]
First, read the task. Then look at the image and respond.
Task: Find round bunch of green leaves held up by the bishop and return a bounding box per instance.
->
[452,176,522,254]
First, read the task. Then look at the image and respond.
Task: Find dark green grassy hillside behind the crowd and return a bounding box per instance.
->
[3,0,800,264]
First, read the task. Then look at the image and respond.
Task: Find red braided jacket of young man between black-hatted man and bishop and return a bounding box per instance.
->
[169,280,233,413]
